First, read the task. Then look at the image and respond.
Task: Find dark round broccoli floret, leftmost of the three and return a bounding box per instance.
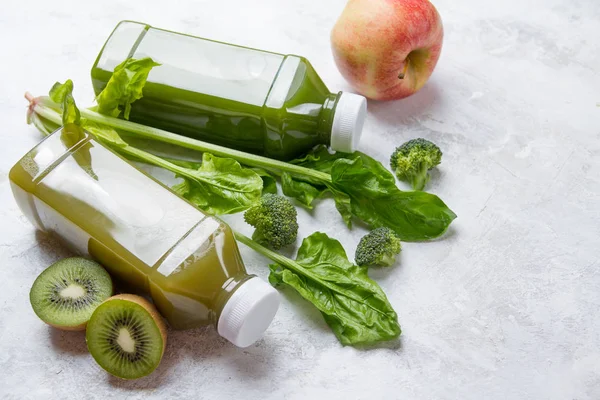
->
[244,193,298,250]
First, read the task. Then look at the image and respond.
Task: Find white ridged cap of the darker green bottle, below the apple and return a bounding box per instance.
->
[331,92,367,153]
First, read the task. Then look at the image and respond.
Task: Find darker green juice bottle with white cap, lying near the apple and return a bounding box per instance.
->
[92,21,367,160]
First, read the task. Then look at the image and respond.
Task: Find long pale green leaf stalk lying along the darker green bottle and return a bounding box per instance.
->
[34,102,331,184]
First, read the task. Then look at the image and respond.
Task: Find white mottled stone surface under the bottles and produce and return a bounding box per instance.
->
[0,0,600,400]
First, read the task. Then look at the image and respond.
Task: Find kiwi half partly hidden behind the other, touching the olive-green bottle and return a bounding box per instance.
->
[29,257,113,331]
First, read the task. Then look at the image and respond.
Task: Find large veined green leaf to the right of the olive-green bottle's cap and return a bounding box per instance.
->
[269,232,401,345]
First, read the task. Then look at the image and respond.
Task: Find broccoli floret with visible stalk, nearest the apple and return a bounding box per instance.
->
[390,138,442,190]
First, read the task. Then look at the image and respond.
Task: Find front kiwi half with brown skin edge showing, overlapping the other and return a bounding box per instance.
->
[86,294,167,379]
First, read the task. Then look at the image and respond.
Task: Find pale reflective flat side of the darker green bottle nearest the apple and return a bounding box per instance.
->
[96,21,283,107]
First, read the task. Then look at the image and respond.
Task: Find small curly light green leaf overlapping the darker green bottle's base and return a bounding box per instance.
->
[96,57,160,119]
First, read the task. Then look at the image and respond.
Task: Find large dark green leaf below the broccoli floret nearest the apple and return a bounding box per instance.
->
[331,156,456,241]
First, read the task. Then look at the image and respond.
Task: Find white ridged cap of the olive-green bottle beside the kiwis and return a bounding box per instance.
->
[217,277,280,347]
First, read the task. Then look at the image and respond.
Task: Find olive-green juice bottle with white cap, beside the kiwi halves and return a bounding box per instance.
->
[9,130,279,347]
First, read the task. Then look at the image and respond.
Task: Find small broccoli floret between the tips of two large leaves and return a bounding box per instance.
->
[354,227,402,267]
